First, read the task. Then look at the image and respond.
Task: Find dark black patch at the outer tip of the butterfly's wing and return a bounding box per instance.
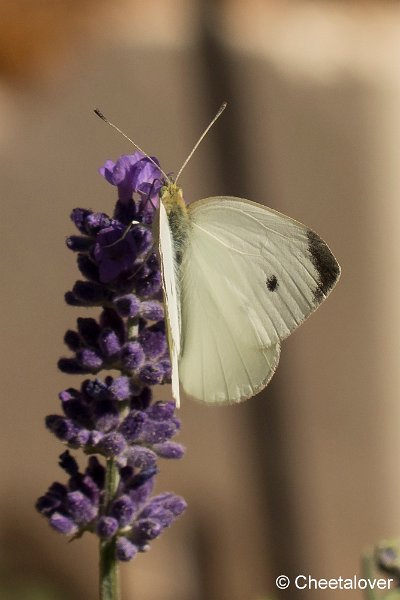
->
[307,231,340,304]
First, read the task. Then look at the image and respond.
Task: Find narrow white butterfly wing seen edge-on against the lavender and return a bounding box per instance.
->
[156,202,181,407]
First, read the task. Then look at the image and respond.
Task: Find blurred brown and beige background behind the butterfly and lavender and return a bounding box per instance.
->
[0,0,400,600]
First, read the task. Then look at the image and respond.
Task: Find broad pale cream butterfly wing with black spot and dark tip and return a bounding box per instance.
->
[178,196,340,404]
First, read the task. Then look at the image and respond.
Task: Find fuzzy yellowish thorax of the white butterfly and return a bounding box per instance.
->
[160,183,189,265]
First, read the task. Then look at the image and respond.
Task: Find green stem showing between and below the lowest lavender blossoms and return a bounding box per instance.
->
[100,459,121,600]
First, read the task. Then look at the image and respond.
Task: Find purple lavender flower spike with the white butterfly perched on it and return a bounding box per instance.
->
[36,152,186,600]
